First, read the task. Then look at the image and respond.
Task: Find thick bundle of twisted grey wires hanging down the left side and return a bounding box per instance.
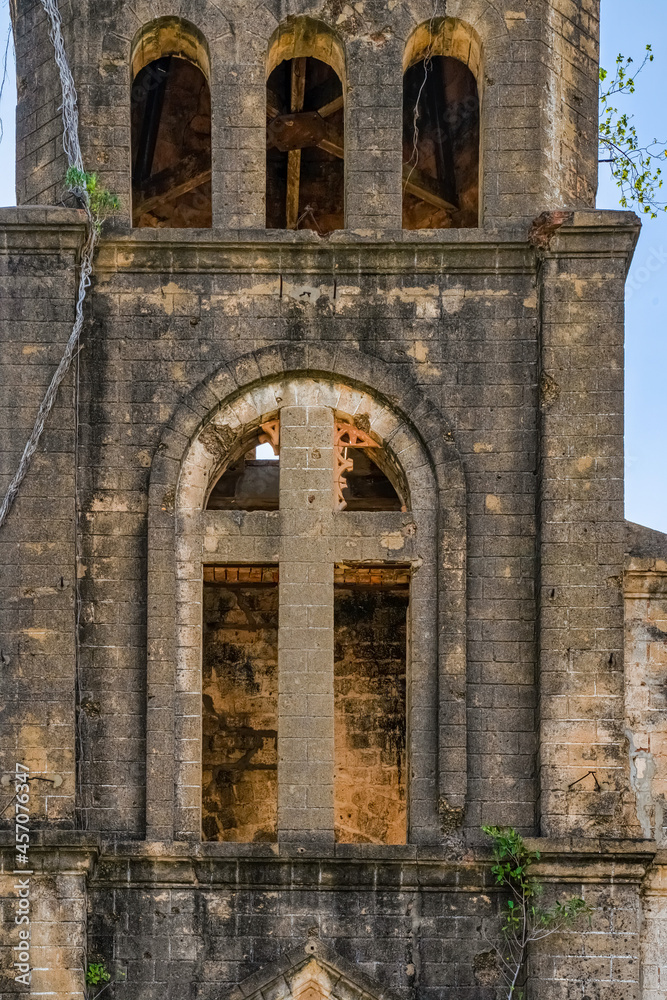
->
[0,0,99,528]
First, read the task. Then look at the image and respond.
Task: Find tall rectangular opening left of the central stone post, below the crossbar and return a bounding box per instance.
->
[202,567,278,843]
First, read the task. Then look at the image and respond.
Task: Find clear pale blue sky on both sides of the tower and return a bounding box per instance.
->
[0,0,667,531]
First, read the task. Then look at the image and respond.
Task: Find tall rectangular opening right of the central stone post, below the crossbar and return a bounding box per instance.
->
[334,580,409,844]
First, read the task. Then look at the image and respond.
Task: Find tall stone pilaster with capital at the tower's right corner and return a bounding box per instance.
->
[539,212,637,837]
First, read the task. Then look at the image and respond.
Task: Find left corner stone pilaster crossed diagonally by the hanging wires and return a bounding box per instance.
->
[0,206,84,828]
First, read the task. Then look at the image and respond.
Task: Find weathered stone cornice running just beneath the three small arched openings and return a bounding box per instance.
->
[0,205,640,278]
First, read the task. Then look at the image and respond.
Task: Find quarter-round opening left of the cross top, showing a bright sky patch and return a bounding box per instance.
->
[206,421,280,511]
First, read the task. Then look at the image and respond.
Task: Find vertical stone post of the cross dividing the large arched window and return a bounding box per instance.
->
[278,405,334,844]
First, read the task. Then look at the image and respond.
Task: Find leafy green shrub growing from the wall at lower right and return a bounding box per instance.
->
[482,826,591,1000]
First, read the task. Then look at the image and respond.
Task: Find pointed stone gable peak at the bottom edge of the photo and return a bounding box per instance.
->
[228,940,397,1000]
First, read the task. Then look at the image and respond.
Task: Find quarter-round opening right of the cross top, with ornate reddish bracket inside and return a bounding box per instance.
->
[334,420,407,511]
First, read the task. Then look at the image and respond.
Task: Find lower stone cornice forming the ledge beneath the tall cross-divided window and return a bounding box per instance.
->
[0,831,664,892]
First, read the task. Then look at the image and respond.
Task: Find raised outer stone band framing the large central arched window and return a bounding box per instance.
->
[147,344,467,840]
